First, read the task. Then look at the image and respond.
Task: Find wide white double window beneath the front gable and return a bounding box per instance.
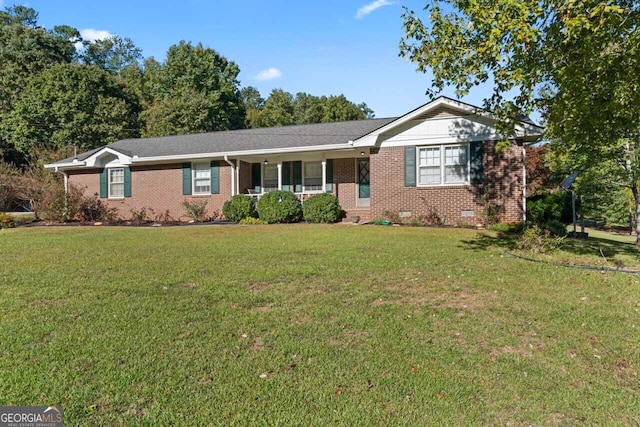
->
[418,144,469,185]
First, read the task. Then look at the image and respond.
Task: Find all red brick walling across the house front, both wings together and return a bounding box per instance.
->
[69,143,523,225]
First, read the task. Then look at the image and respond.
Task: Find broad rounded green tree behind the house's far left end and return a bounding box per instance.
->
[1,64,138,156]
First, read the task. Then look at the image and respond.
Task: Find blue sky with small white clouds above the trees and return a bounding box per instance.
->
[0,0,496,117]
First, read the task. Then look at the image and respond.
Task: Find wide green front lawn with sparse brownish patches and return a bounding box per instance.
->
[0,225,640,426]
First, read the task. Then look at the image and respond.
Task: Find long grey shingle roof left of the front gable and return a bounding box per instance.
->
[65,117,395,163]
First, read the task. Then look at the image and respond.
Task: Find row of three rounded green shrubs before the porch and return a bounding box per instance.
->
[222,191,342,224]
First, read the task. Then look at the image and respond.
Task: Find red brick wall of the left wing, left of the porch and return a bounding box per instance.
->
[69,162,231,221]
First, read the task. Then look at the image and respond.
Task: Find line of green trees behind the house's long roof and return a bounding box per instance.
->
[0,6,373,166]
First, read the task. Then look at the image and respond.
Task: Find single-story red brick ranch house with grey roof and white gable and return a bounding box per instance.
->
[45,97,542,225]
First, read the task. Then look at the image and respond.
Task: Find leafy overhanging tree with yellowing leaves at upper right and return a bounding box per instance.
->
[400,0,640,242]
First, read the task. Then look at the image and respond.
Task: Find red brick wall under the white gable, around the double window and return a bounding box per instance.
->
[370,143,523,225]
